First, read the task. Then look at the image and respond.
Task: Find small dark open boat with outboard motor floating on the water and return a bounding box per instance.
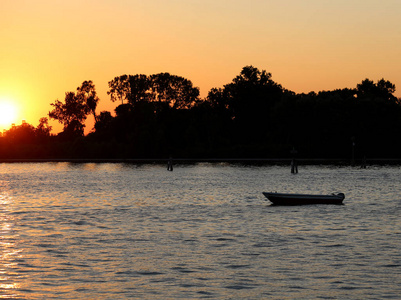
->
[263,193,345,205]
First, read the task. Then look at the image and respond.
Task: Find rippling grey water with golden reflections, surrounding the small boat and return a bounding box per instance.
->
[0,163,401,299]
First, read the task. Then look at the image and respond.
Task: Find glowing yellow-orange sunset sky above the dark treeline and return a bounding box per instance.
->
[0,0,401,132]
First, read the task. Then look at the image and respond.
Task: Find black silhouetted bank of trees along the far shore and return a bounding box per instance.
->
[0,66,401,159]
